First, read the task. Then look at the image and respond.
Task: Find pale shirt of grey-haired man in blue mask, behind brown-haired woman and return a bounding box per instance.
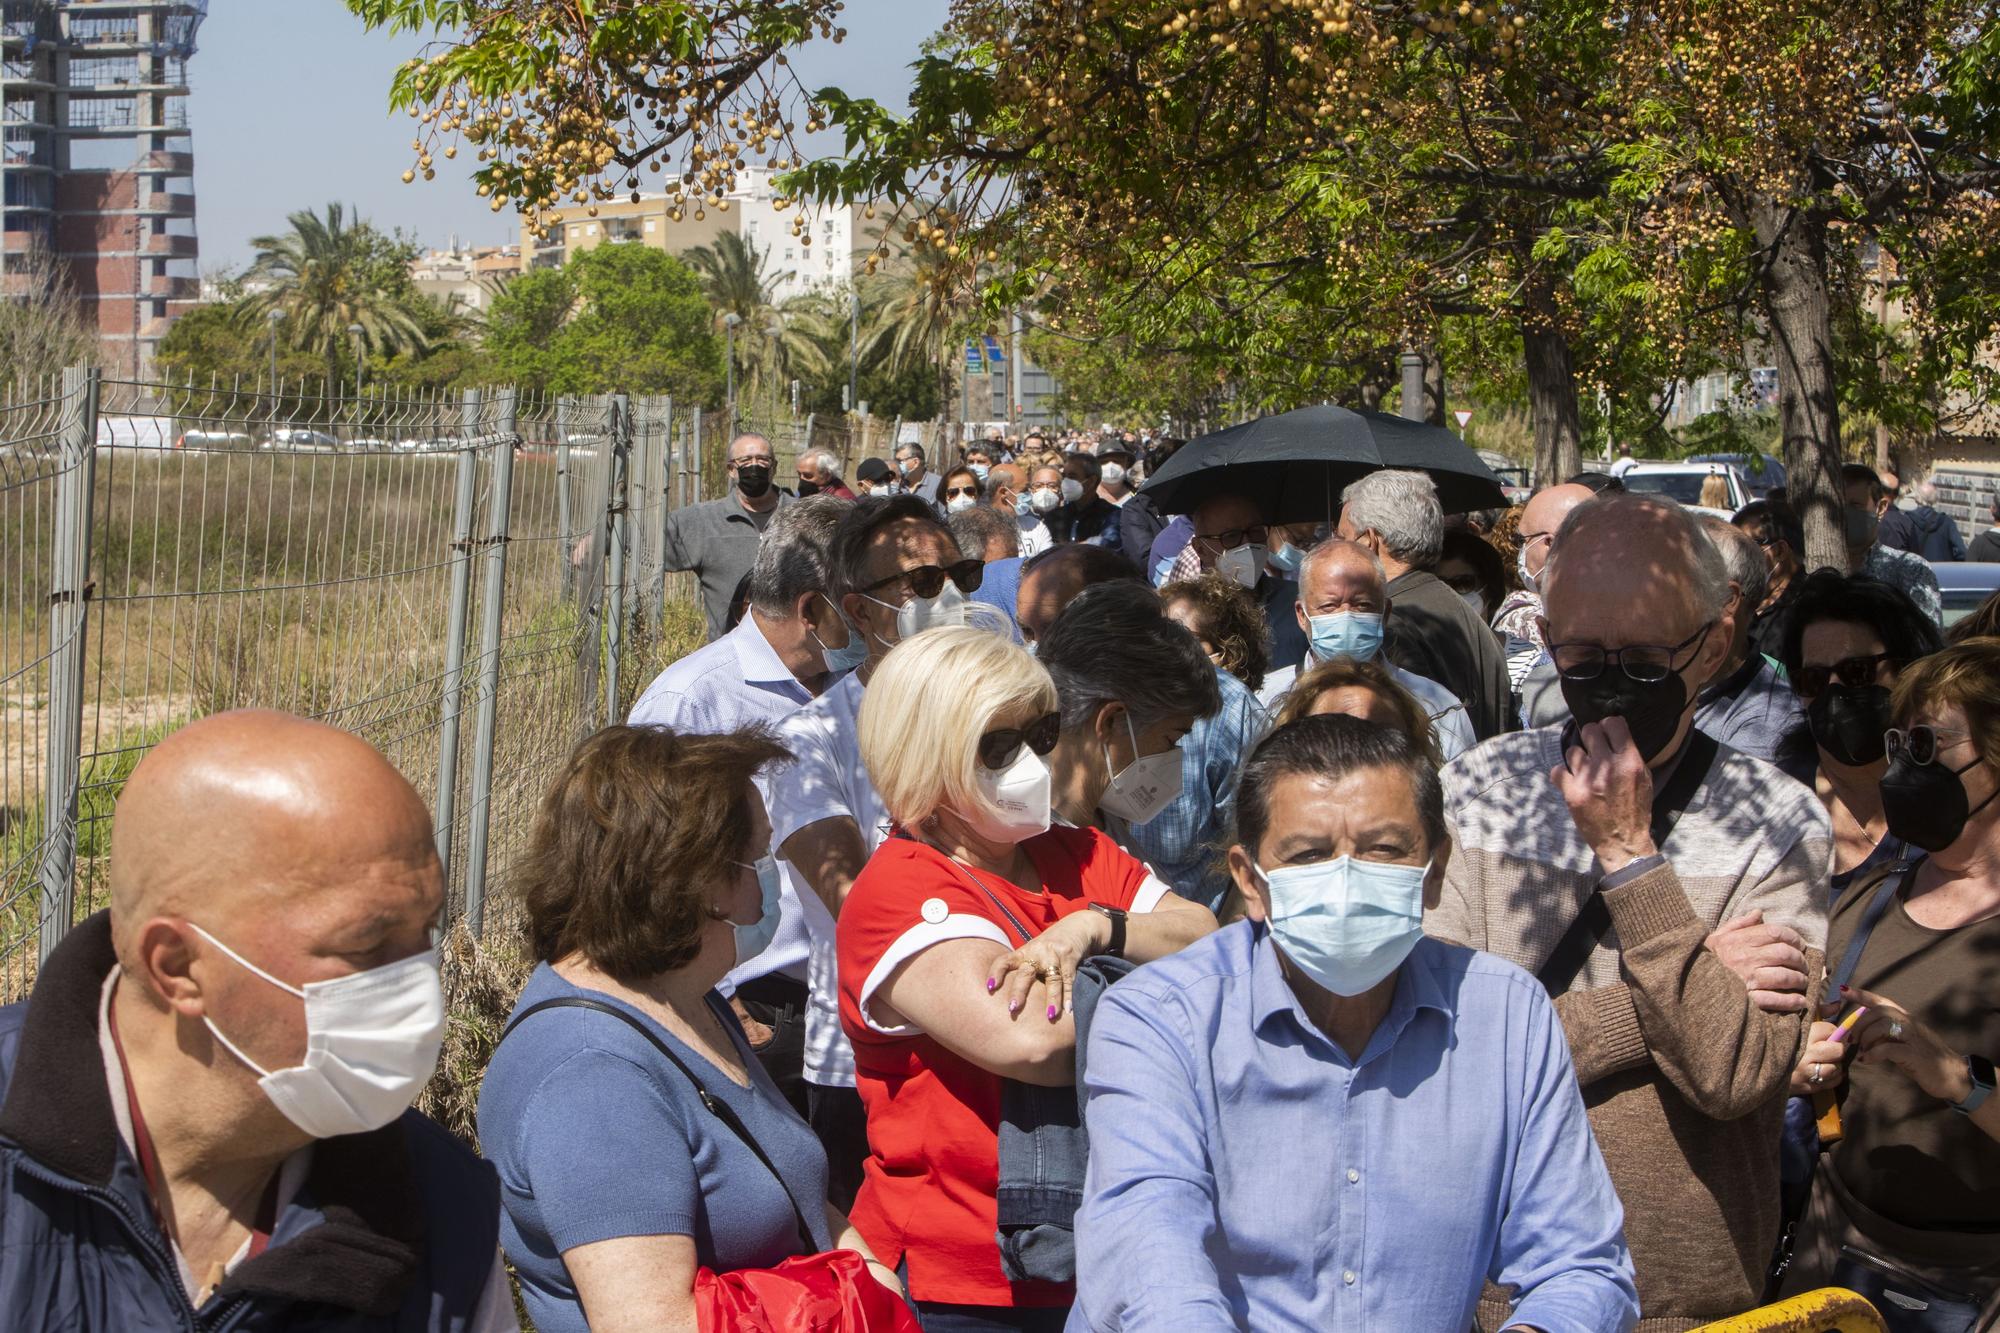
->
[626,610,812,995]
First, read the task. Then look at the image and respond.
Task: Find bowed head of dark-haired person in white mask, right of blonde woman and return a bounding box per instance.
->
[1036,582,1222,851]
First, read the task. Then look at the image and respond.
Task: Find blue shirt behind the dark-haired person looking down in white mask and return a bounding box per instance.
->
[1116,669,1270,911]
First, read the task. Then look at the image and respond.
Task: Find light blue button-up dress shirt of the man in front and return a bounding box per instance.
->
[1068,921,1638,1333]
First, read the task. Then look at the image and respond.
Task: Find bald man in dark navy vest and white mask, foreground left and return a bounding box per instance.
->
[0,713,516,1333]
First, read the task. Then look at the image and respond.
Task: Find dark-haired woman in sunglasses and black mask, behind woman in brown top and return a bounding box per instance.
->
[1784,568,1944,899]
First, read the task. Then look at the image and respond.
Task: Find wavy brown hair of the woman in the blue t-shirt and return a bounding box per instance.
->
[518,727,790,985]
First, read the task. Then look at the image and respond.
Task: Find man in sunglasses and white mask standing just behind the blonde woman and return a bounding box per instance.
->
[764,492,988,1211]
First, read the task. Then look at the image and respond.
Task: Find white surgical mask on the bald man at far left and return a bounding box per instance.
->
[188,921,444,1139]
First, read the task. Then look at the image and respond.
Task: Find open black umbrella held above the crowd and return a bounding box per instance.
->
[1140,406,1506,522]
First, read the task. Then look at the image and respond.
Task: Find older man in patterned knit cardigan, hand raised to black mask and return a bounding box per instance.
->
[1424,494,1832,1331]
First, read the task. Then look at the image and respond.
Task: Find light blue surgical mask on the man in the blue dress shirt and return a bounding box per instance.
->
[1256,857,1430,995]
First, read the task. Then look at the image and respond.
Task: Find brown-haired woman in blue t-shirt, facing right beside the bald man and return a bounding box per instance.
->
[480,727,900,1333]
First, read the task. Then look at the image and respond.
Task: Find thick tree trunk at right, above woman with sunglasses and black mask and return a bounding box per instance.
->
[1750,200,1848,568]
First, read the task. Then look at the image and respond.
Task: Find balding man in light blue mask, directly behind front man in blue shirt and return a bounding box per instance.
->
[1258,536,1474,761]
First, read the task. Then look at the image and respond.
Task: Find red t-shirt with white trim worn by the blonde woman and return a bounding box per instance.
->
[840,827,1168,1307]
